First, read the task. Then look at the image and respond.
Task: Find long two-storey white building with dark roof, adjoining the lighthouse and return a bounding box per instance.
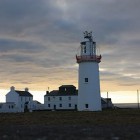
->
[44,85,78,110]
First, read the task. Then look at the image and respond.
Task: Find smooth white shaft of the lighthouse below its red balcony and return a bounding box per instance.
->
[78,62,101,111]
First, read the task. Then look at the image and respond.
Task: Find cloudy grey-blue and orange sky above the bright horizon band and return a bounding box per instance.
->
[0,0,140,103]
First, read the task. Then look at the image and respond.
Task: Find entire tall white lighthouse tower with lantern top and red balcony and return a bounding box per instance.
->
[76,31,102,111]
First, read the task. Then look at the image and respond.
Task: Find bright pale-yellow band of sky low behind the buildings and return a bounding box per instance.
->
[0,88,140,104]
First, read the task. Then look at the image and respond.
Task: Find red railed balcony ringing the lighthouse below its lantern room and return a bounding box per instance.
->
[76,55,102,63]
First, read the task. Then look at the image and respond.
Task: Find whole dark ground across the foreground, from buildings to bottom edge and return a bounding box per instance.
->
[0,109,140,140]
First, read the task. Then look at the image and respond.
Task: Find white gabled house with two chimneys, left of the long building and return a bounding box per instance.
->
[6,87,33,112]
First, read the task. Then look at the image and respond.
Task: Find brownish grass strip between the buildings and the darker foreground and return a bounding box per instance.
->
[0,109,140,125]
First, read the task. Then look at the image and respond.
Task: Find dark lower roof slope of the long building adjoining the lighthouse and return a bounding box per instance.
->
[45,90,78,96]
